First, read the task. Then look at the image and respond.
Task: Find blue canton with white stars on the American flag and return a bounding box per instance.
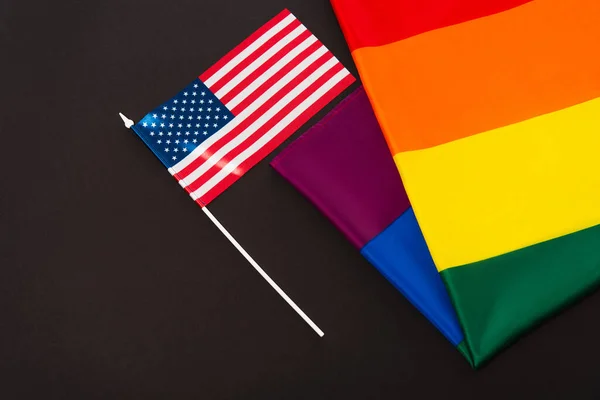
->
[133,79,233,168]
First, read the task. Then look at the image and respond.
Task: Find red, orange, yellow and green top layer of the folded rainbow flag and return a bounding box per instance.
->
[332,0,600,367]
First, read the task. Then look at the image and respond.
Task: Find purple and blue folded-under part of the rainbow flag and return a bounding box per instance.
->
[271,87,465,354]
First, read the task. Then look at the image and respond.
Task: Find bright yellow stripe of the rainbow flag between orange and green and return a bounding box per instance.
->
[394,98,600,271]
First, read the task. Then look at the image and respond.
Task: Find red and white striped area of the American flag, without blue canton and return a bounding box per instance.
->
[169,10,349,205]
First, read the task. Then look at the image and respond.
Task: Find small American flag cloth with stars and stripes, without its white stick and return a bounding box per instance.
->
[133,10,354,206]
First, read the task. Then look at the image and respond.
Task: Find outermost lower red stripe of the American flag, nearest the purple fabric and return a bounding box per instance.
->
[197,74,355,206]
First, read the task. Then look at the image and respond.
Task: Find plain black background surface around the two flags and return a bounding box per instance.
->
[0,0,600,399]
